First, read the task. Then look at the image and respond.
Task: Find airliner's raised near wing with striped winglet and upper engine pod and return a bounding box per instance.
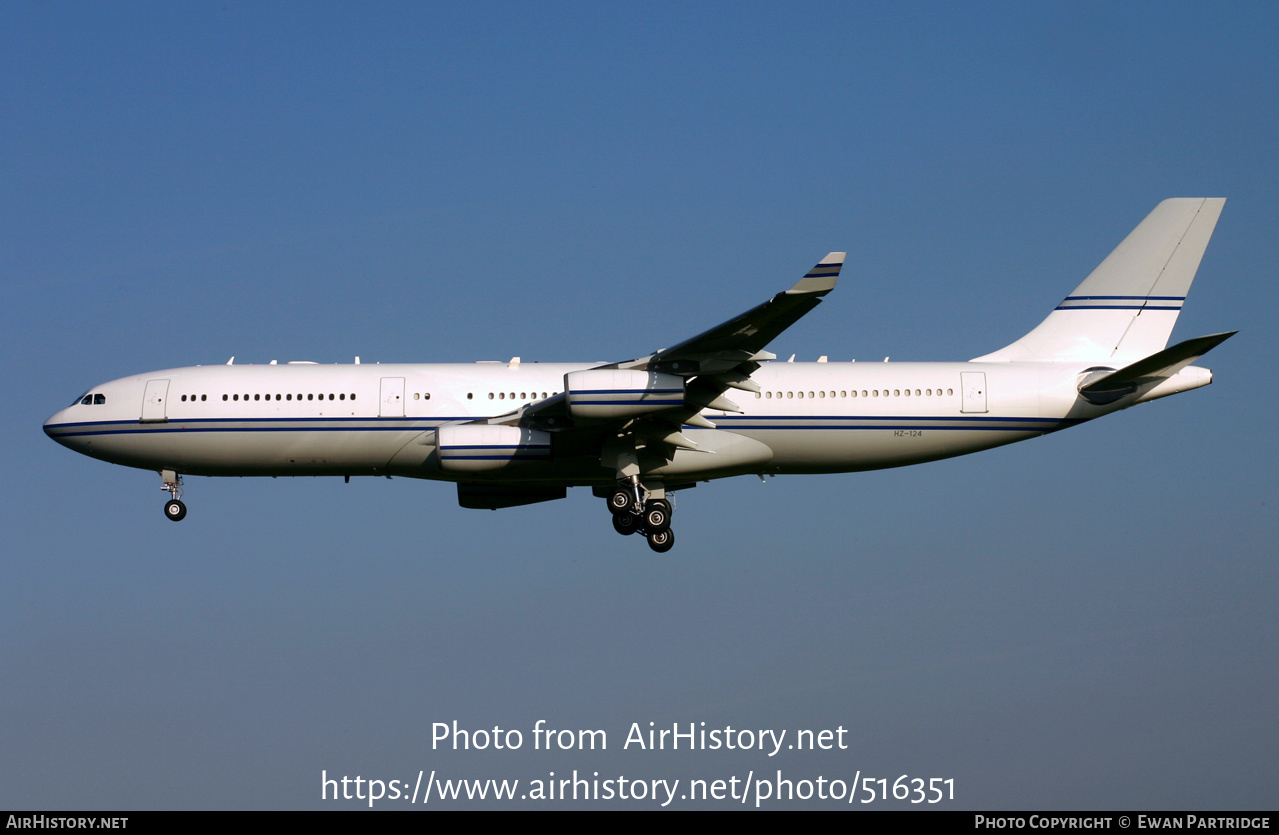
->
[490,252,847,439]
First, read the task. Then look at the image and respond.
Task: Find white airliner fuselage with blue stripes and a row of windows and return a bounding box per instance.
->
[45,362,1151,485]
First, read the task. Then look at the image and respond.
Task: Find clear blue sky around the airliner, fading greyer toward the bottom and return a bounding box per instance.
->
[0,3,1279,808]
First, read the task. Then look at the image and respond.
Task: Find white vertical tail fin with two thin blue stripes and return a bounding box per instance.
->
[973,197,1225,366]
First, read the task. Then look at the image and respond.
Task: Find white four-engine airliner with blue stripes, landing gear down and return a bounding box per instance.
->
[45,198,1236,552]
